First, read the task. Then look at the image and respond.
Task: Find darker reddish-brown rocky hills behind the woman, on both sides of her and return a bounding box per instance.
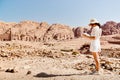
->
[73,21,120,37]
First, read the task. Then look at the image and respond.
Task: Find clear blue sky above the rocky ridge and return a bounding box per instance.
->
[0,0,120,27]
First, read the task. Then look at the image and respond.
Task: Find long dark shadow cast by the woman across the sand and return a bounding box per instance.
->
[34,72,87,78]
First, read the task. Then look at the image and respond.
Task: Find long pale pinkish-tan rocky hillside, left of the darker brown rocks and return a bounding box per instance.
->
[0,21,74,41]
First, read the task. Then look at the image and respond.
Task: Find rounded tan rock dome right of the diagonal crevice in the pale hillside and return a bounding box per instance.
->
[44,24,74,40]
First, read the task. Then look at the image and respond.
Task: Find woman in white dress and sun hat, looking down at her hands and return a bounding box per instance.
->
[82,19,102,73]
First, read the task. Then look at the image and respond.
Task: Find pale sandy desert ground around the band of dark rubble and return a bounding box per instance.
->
[0,39,120,80]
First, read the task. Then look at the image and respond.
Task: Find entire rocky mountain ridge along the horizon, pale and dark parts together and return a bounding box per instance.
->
[0,21,120,41]
